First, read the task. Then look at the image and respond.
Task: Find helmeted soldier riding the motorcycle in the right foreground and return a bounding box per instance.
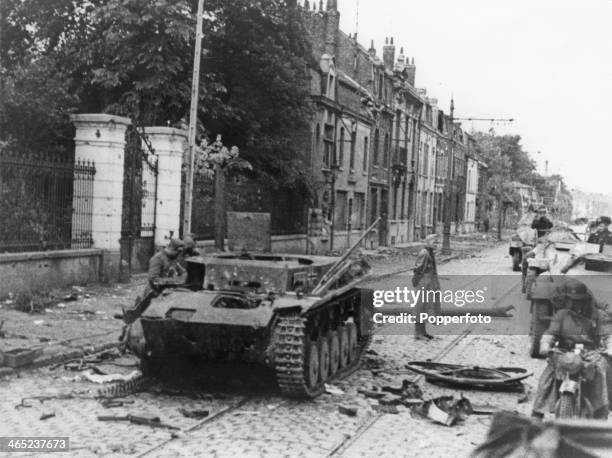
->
[532,277,612,419]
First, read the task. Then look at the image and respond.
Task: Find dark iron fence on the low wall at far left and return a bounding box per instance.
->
[0,149,95,252]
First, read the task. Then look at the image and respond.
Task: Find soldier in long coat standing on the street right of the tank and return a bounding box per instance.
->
[412,234,440,339]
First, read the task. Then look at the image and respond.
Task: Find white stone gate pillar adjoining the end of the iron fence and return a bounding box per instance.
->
[70,113,131,281]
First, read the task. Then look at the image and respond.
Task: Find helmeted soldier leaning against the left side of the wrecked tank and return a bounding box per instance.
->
[123,239,185,324]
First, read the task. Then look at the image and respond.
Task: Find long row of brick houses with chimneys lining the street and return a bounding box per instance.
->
[300,0,478,250]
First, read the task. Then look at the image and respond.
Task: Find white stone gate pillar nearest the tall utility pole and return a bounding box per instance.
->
[145,127,187,247]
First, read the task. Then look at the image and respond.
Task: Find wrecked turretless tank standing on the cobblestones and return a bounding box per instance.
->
[125,214,373,397]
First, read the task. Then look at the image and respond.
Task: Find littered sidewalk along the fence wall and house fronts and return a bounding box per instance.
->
[0,234,506,375]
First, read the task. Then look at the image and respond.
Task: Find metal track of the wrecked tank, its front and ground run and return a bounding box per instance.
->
[274,312,372,398]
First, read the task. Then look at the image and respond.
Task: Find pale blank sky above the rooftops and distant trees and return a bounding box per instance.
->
[332,0,612,194]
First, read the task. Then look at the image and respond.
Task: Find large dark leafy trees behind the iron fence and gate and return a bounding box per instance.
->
[0,0,312,191]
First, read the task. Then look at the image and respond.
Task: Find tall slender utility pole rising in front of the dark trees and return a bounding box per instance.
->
[183,0,206,235]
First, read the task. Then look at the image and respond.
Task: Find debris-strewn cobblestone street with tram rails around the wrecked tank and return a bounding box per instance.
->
[0,245,592,457]
